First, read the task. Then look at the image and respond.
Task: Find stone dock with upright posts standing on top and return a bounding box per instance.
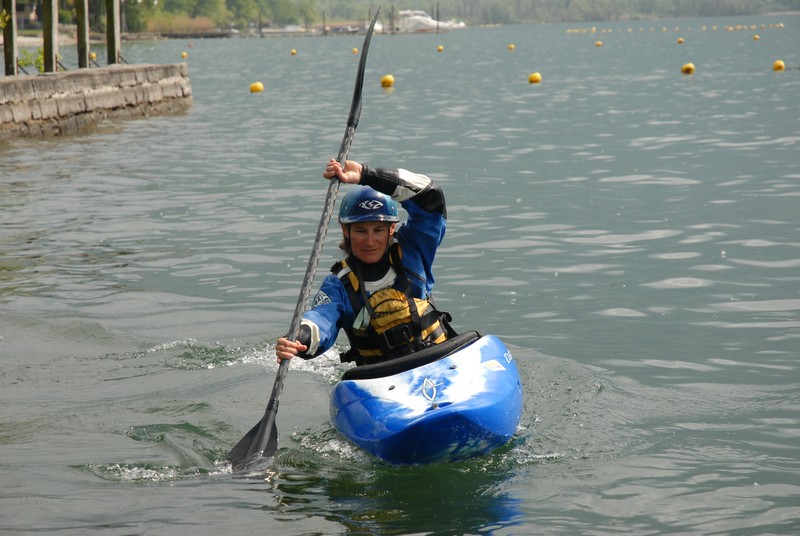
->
[0,0,192,141]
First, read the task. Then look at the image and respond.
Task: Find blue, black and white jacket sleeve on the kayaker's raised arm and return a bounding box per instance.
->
[361,166,447,298]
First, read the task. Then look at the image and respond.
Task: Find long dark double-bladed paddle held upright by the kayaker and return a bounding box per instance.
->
[228,8,380,471]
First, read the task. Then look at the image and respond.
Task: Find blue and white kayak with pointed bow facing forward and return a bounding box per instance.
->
[331,331,522,465]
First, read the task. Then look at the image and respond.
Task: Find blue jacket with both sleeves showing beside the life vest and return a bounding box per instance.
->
[303,166,447,357]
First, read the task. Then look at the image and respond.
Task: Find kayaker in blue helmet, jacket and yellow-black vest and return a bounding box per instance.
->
[276,160,455,365]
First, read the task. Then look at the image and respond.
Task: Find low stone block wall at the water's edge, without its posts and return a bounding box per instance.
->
[0,63,192,140]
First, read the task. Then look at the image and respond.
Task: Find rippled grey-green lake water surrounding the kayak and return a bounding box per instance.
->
[0,15,800,535]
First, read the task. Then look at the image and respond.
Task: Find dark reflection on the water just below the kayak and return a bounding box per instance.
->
[268,450,521,534]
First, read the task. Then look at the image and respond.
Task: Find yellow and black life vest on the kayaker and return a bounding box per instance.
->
[331,243,455,365]
